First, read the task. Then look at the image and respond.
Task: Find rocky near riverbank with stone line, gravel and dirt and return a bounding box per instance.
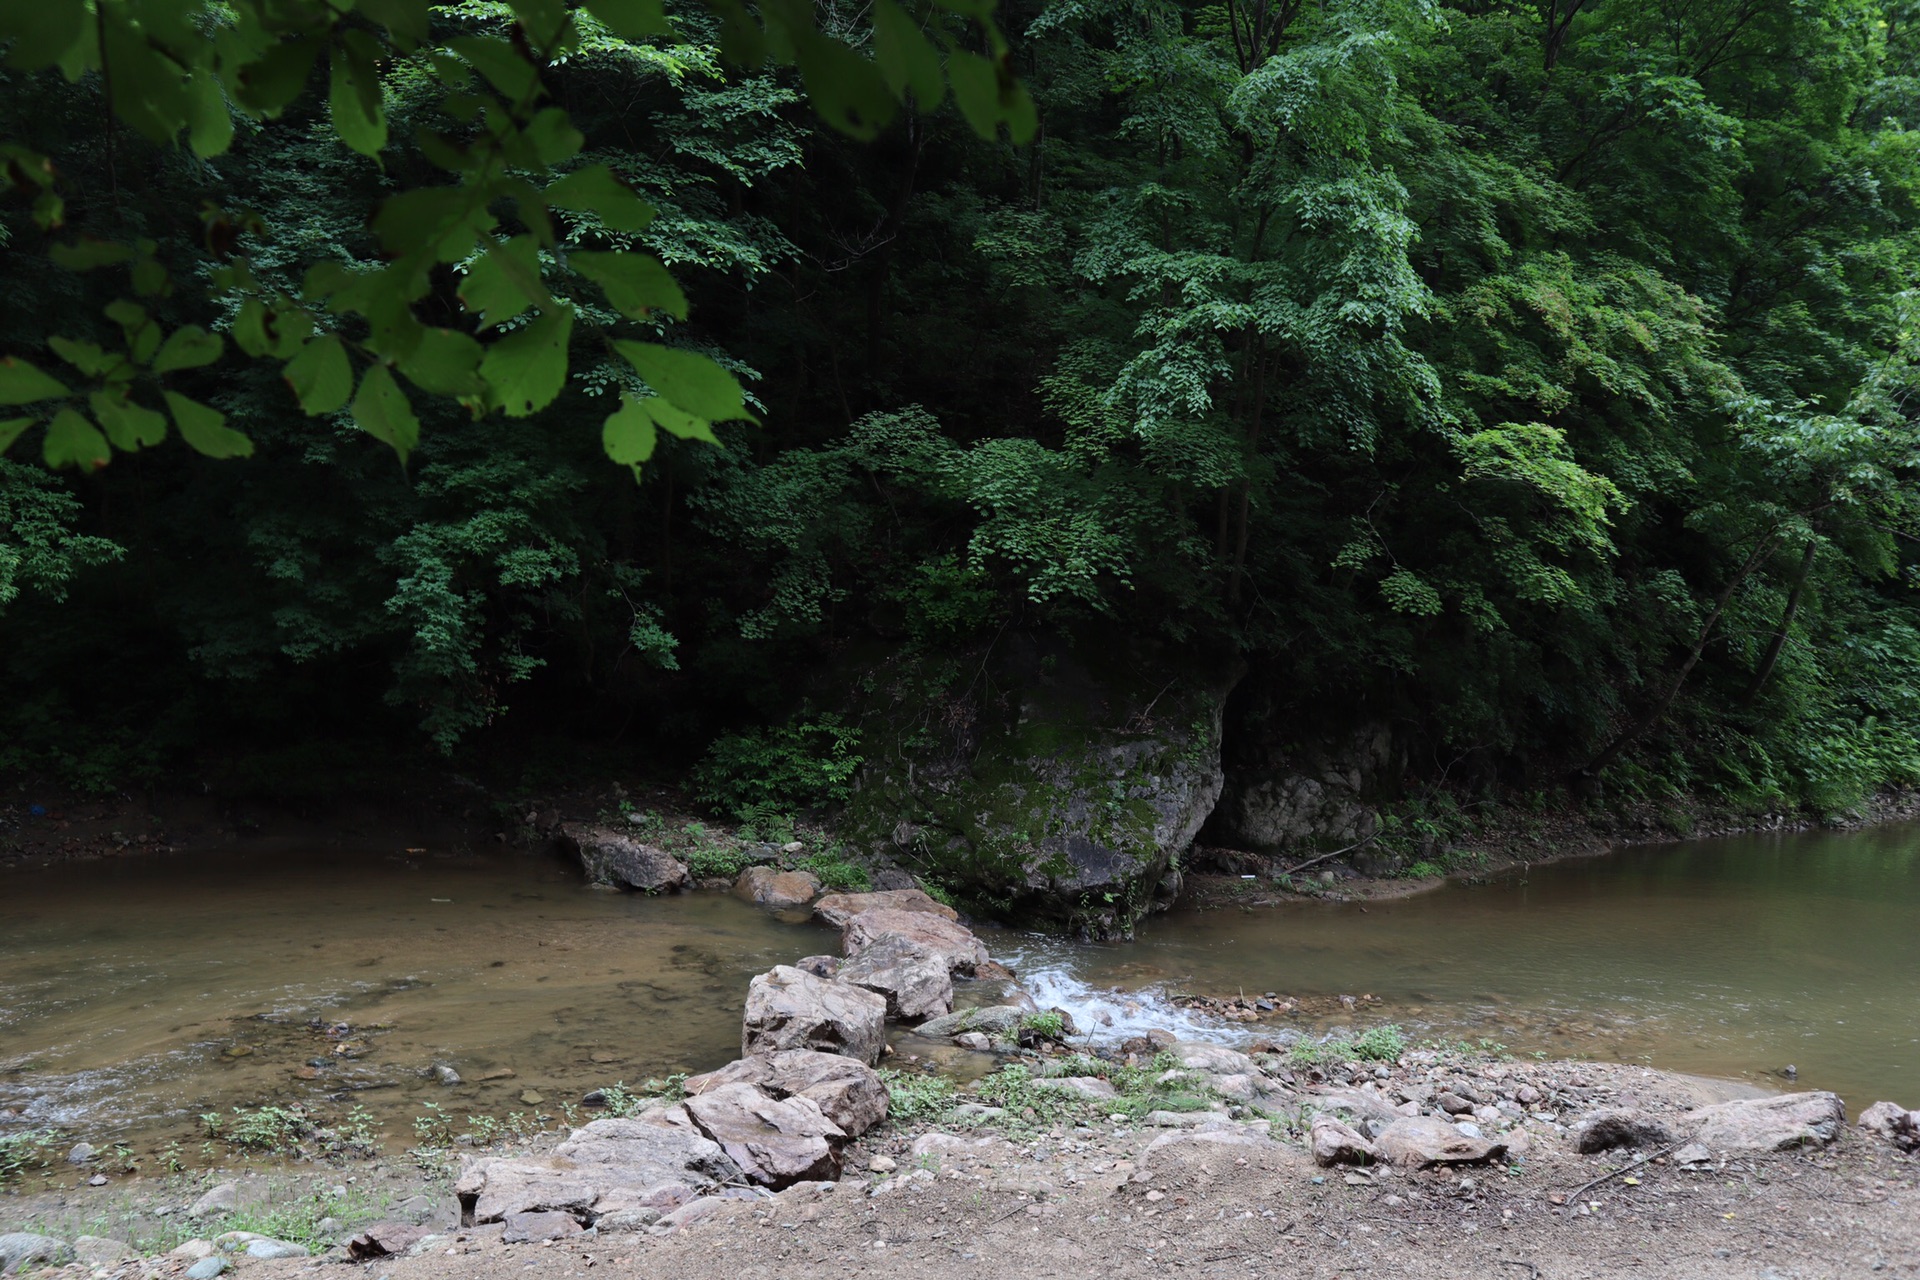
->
[0,877,1920,1280]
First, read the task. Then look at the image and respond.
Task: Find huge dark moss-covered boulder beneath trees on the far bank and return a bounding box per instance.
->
[847,635,1240,938]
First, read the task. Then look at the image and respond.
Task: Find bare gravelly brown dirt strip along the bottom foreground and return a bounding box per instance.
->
[15,1061,1920,1280]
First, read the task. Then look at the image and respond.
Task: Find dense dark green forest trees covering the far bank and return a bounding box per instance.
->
[0,0,1920,810]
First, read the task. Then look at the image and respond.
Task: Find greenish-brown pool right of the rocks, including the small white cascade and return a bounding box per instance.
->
[995,825,1920,1113]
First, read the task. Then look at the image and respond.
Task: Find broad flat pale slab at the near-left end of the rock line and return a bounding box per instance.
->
[453,1107,741,1226]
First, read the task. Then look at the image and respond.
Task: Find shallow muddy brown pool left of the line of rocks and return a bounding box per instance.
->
[0,850,817,1148]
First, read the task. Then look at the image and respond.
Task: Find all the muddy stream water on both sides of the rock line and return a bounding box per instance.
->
[0,827,1920,1150]
